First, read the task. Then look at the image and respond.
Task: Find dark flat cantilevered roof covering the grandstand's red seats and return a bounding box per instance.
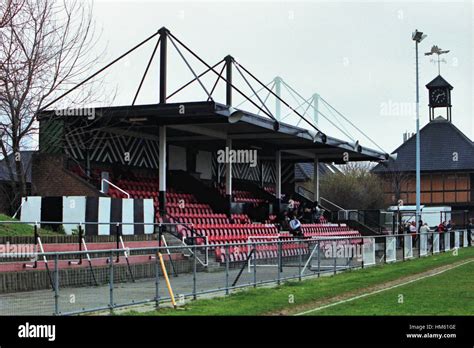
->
[39,101,386,163]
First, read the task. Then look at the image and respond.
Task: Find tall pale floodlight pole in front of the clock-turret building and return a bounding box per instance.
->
[412,30,425,233]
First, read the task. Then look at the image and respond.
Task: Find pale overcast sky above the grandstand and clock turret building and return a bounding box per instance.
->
[76,0,474,152]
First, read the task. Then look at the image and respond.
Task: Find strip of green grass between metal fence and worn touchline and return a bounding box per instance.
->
[125,248,474,315]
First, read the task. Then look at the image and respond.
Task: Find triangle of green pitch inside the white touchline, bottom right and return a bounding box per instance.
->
[308,262,474,315]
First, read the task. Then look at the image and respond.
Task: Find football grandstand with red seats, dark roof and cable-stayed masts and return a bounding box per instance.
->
[0,28,394,316]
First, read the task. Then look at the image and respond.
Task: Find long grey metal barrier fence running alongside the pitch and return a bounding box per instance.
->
[0,230,472,315]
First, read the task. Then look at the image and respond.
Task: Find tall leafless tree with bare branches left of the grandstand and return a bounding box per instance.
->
[0,0,103,212]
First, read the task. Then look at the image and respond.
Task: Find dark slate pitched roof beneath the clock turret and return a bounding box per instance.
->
[373,116,474,173]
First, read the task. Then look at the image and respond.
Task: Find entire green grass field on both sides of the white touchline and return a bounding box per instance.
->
[125,248,474,315]
